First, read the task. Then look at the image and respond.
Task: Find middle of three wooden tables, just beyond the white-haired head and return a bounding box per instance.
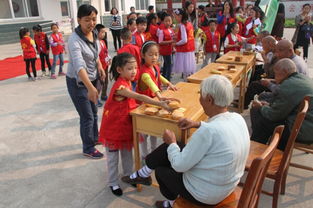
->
[187,63,245,87]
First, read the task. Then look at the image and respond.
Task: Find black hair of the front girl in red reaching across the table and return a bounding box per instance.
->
[110,53,136,81]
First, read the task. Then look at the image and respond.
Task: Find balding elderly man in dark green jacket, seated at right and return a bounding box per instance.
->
[250,58,313,150]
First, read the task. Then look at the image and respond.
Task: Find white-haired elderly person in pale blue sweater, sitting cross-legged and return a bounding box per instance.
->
[122,75,250,207]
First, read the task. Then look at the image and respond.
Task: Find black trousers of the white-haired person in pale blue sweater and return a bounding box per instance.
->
[146,143,205,206]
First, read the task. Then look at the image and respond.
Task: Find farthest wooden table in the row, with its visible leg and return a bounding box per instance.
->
[216,51,256,113]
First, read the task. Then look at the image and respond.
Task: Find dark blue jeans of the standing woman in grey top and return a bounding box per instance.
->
[66,77,98,153]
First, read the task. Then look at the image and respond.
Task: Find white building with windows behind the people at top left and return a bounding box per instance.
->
[0,0,155,44]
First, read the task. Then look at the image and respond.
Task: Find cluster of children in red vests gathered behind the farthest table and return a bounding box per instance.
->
[199,1,262,67]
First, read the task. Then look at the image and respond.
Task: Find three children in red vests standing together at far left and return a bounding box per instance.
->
[19,23,65,81]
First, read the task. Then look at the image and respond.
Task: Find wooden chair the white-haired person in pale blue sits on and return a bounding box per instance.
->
[173,126,284,208]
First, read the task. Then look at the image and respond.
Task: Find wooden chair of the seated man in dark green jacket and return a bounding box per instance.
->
[246,97,310,208]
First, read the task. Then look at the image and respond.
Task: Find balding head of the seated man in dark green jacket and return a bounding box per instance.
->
[274,58,297,84]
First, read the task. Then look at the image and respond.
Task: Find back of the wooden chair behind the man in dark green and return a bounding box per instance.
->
[277,96,311,174]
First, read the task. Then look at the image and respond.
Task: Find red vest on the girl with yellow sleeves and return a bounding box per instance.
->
[137,64,161,98]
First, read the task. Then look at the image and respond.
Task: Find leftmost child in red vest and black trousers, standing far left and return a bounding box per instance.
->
[19,27,37,81]
